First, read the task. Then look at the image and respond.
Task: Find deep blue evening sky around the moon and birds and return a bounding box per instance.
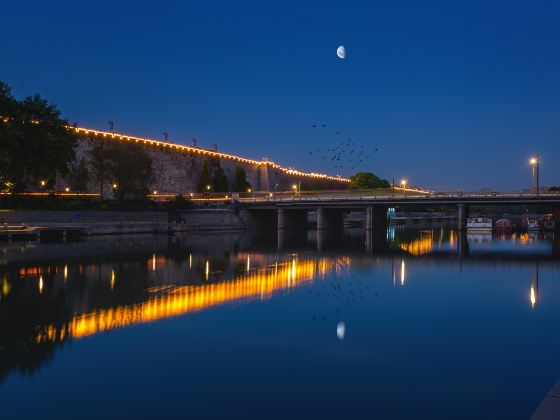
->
[0,0,560,189]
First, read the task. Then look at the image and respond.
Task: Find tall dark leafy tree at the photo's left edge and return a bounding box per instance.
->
[0,82,78,191]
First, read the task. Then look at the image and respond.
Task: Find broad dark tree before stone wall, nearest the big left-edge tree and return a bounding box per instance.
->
[88,140,153,200]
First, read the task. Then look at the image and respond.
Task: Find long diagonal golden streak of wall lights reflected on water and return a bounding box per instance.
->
[36,257,350,343]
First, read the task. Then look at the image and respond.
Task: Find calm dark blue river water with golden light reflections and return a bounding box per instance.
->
[0,229,560,419]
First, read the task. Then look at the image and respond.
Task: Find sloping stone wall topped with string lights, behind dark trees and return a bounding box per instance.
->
[64,135,347,197]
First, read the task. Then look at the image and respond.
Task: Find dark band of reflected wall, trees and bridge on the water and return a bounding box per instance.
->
[0,229,560,379]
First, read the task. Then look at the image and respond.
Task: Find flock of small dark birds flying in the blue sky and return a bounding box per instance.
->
[307,123,379,172]
